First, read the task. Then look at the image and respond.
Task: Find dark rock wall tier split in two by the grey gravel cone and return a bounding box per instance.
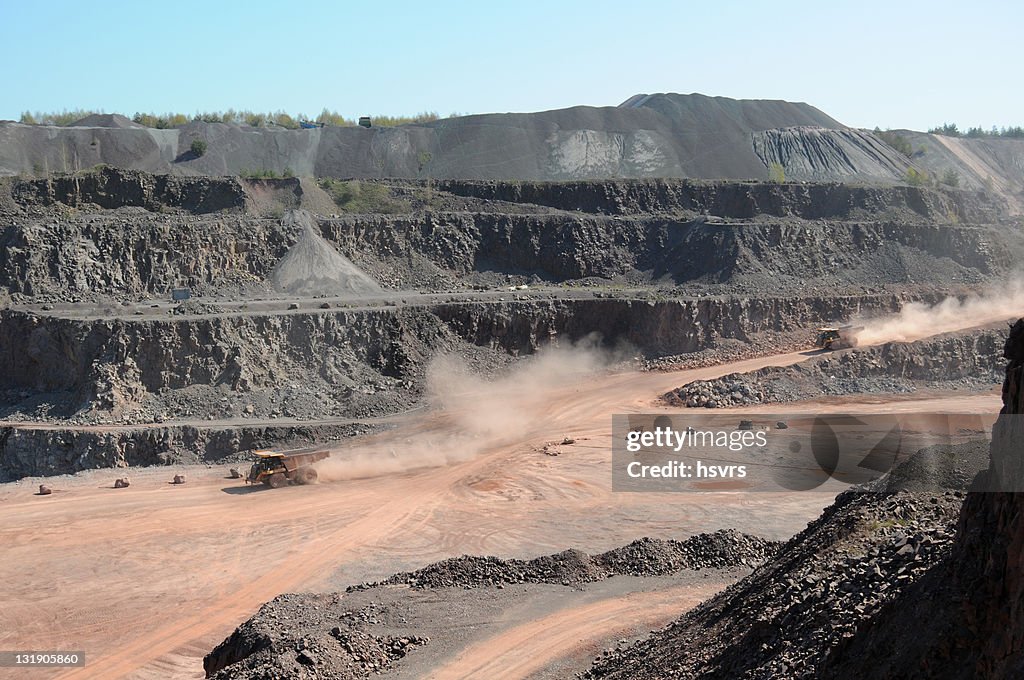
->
[0,185,1007,300]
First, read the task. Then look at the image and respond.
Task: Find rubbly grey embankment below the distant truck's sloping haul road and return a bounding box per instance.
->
[664,329,1005,409]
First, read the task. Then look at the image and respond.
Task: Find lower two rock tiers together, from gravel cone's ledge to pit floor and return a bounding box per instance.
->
[0,296,917,480]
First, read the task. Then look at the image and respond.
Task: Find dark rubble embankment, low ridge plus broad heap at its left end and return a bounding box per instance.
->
[203,530,777,680]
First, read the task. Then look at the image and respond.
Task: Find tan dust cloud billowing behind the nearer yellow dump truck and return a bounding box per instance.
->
[316,341,615,480]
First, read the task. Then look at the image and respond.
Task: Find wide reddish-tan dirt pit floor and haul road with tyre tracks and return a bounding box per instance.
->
[0,353,998,679]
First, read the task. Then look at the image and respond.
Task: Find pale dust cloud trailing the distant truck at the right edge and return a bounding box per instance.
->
[855,279,1024,345]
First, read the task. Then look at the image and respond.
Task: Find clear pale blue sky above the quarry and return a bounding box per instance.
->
[0,0,1024,129]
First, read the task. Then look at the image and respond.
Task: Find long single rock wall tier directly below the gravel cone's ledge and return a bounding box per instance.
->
[0,296,913,397]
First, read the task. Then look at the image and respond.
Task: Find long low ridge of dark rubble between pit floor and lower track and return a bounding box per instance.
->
[348,529,778,591]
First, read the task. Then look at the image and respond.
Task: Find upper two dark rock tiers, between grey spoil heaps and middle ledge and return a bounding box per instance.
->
[0,170,1011,300]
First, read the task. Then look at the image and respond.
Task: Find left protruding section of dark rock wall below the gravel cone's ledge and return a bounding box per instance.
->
[0,309,452,398]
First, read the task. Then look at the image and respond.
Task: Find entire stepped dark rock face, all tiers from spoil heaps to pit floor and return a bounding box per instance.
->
[0,173,1024,477]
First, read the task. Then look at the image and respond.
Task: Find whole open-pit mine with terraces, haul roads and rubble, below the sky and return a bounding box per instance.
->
[0,95,1024,680]
